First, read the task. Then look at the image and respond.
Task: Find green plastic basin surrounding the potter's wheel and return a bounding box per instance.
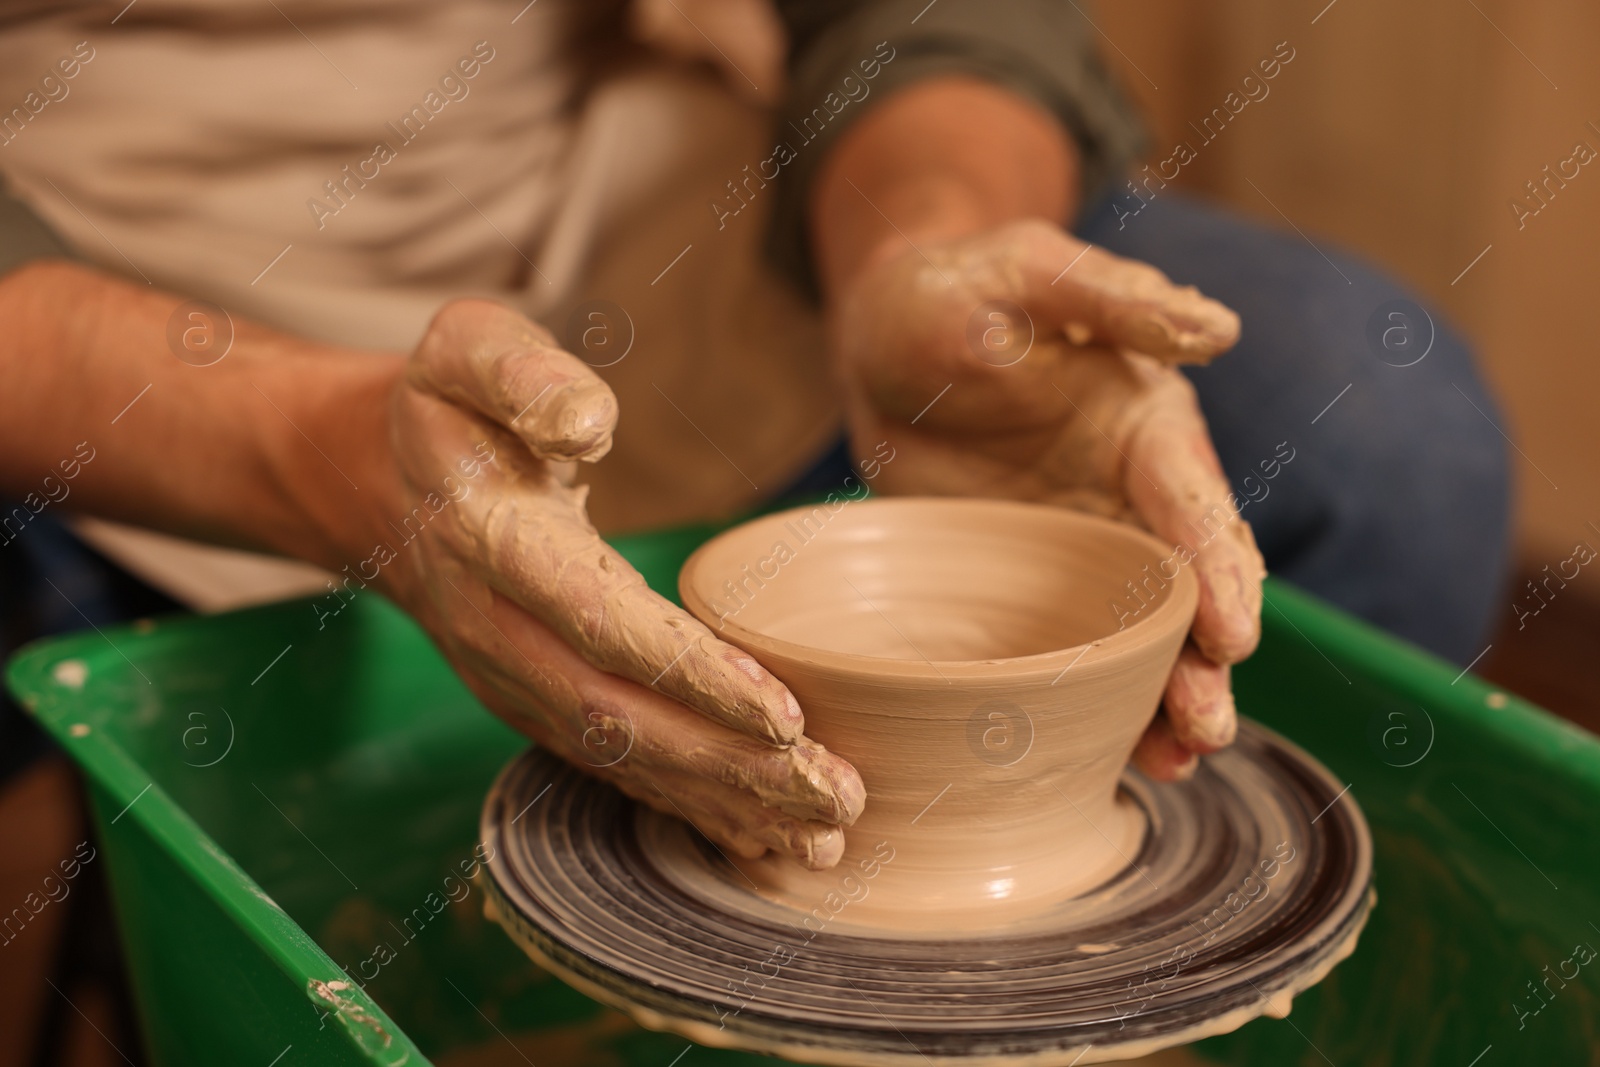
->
[8,528,1600,1067]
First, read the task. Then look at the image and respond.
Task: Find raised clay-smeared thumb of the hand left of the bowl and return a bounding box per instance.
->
[406,299,616,462]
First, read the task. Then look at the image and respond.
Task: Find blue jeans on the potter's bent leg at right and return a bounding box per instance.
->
[802,192,1510,664]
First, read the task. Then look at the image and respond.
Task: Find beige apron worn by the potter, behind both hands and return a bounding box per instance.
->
[0,0,840,609]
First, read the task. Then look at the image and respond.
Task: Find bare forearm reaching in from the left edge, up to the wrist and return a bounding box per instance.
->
[0,261,403,568]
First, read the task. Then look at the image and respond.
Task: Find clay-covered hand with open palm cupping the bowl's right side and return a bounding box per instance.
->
[829,221,1266,779]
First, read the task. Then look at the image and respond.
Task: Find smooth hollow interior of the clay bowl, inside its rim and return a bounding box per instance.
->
[683,499,1176,662]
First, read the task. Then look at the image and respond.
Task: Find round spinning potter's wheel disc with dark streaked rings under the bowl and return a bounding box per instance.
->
[482,721,1373,1065]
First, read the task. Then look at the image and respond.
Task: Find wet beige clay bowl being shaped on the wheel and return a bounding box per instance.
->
[678,499,1198,936]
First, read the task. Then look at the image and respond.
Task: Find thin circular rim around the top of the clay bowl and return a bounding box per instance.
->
[678,496,1200,683]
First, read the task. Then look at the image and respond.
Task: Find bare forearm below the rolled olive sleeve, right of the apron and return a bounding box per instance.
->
[810,77,1080,299]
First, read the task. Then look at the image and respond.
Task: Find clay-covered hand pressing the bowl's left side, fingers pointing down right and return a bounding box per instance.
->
[368,301,866,867]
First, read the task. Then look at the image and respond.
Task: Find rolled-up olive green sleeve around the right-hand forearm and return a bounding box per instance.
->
[766,0,1144,296]
